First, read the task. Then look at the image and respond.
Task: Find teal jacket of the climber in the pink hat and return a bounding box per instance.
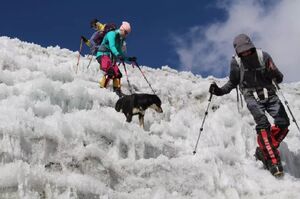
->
[96,29,125,58]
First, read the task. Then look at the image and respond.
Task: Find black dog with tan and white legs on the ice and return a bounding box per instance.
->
[115,93,163,128]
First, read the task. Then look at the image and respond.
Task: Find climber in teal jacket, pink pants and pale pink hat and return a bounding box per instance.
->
[96,21,136,97]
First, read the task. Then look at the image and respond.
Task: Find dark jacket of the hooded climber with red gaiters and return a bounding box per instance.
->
[221,52,283,94]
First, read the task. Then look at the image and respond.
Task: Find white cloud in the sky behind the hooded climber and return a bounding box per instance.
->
[174,0,300,82]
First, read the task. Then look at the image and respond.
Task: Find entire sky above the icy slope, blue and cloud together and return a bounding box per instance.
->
[0,0,300,81]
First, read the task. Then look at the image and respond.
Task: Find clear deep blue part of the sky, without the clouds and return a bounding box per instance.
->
[0,0,224,74]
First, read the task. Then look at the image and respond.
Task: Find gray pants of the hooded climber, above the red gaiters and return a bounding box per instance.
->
[245,95,290,131]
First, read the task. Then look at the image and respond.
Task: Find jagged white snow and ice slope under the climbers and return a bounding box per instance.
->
[0,37,300,199]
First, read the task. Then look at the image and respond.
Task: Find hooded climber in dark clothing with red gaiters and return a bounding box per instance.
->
[209,34,290,177]
